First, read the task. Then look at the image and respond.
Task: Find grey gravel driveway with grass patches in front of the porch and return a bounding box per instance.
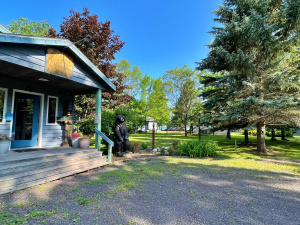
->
[0,156,300,225]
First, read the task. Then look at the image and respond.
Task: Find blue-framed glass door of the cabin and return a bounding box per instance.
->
[11,92,40,147]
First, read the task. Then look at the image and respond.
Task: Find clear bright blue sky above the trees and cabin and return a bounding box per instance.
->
[0,0,222,78]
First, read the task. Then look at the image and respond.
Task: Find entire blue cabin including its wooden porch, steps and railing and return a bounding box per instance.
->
[0,24,116,194]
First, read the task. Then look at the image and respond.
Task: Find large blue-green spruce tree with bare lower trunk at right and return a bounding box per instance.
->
[198,0,300,153]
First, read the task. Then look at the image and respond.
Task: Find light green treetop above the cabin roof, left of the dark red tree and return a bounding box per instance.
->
[7,17,50,36]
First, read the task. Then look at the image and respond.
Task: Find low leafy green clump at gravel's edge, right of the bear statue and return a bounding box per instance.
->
[177,141,218,157]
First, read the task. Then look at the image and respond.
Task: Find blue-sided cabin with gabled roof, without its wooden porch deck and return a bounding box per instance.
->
[0,26,115,148]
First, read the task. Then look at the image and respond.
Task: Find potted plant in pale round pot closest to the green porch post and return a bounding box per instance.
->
[79,119,95,149]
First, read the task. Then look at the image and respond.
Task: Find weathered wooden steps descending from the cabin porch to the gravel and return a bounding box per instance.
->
[0,150,108,194]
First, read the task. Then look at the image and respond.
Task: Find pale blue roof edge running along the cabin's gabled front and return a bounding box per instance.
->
[0,31,116,91]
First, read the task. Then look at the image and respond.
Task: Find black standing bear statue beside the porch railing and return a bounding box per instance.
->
[115,115,129,156]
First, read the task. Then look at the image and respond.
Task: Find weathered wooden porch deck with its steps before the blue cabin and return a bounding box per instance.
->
[0,147,109,194]
